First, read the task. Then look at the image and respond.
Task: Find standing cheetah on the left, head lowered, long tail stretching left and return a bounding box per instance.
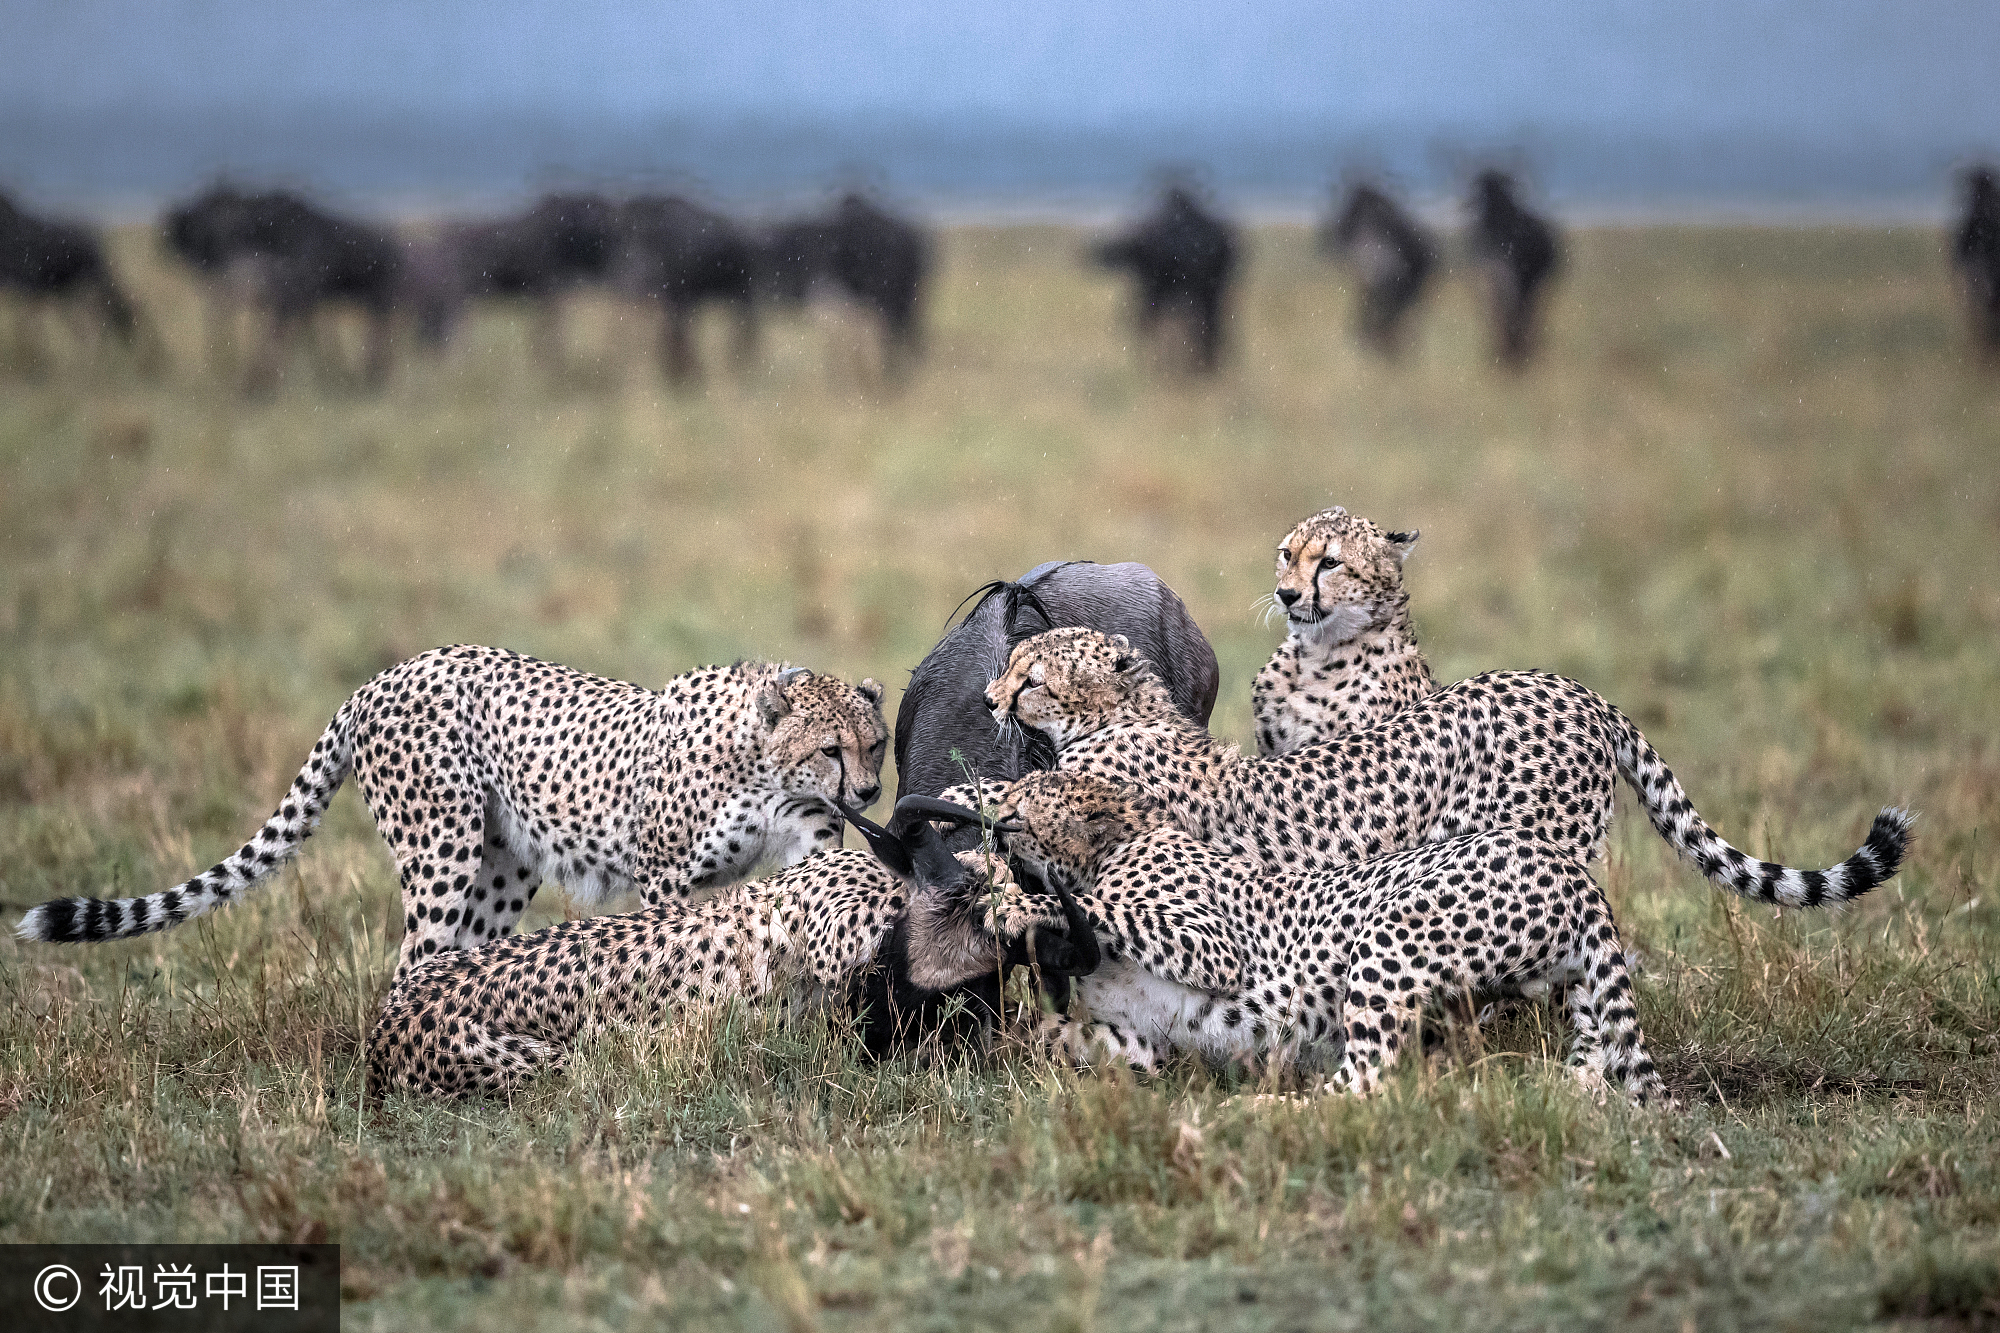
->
[20,646,888,983]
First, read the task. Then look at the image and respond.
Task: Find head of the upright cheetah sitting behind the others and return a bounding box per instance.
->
[1272,506,1418,644]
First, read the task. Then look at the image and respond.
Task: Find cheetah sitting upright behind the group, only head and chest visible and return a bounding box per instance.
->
[1250,506,1438,755]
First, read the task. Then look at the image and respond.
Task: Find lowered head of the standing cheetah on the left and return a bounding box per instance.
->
[758,673,888,811]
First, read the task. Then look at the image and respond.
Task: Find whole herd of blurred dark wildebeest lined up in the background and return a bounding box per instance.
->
[0,166,2000,392]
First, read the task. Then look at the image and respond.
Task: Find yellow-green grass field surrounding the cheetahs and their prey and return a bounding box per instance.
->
[0,226,2000,1331]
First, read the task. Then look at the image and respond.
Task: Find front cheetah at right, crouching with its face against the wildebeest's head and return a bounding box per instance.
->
[998,773,1660,1101]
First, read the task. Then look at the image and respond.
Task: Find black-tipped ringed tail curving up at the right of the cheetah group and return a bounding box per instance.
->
[1612,709,1916,907]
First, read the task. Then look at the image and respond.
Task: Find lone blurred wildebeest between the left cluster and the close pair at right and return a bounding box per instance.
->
[1096,186,1236,374]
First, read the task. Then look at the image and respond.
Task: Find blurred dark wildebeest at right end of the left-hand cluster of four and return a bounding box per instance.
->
[760,194,930,380]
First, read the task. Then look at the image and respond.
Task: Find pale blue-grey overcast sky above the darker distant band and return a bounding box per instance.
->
[0,0,2000,206]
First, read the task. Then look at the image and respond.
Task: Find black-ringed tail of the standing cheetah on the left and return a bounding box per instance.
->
[16,701,354,945]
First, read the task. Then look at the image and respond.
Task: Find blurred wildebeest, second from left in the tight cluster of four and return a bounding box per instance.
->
[402,192,624,366]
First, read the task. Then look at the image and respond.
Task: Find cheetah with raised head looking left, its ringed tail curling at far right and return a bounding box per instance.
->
[986,628,1910,907]
